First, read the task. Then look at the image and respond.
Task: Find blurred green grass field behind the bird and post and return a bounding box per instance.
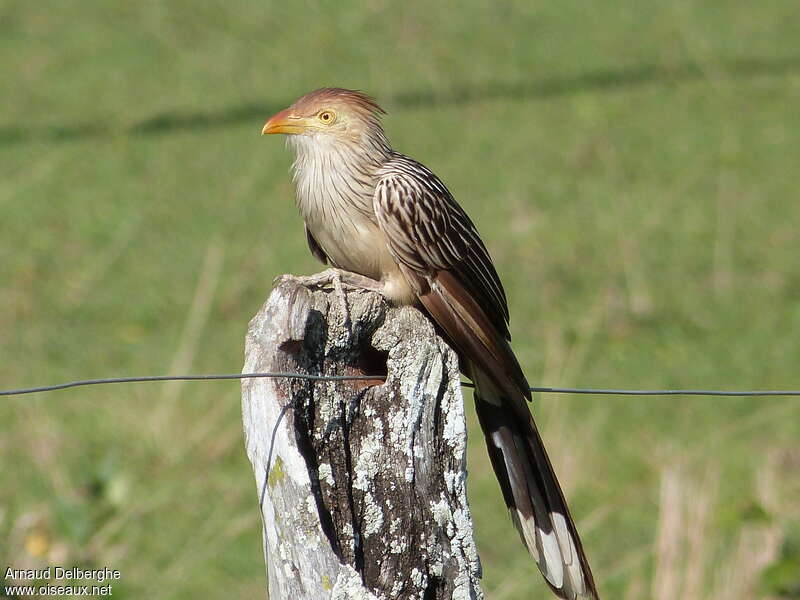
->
[0,0,800,600]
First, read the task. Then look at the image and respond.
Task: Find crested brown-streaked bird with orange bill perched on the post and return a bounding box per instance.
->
[262,87,598,600]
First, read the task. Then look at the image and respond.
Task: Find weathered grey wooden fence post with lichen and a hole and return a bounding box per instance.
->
[242,278,483,600]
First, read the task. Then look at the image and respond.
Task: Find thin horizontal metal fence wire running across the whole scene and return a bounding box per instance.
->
[0,372,800,396]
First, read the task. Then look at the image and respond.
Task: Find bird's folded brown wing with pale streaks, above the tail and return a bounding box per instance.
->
[374,155,530,406]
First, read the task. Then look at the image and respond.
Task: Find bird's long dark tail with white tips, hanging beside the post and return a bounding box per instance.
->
[475,373,598,600]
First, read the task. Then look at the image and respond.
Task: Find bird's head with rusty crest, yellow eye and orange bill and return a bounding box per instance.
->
[261,88,384,141]
